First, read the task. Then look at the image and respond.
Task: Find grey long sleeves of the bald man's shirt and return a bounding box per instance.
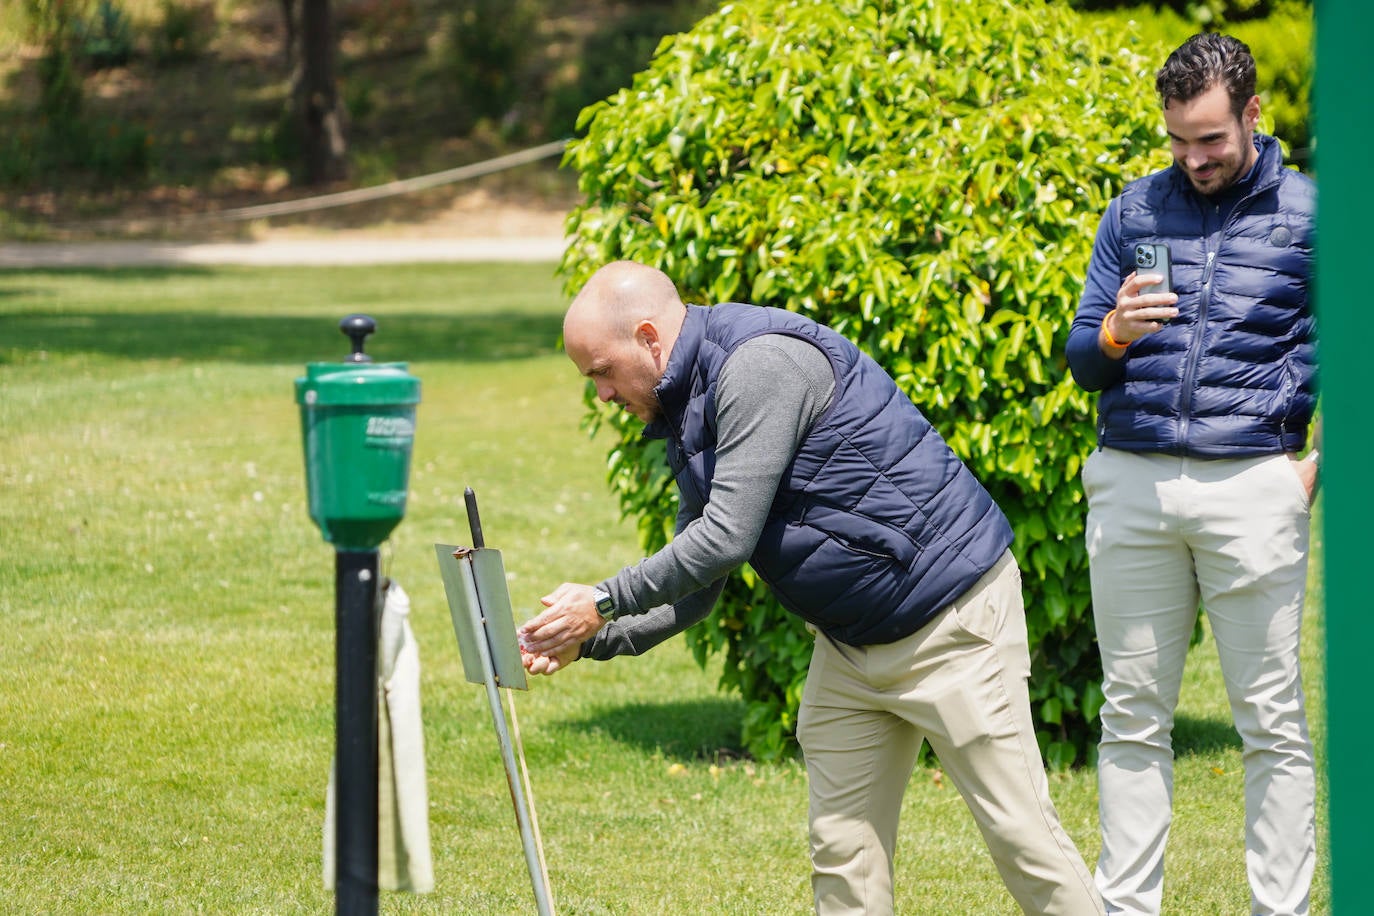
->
[581,334,835,659]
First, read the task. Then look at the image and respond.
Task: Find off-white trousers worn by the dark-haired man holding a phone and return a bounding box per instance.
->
[1083,449,1316,916]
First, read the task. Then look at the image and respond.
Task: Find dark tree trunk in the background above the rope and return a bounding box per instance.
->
[295,0,348,185]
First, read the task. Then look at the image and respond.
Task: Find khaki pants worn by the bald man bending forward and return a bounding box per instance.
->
[797,552,1102,916]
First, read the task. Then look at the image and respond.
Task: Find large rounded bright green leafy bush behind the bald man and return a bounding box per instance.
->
[562,0,1168,766]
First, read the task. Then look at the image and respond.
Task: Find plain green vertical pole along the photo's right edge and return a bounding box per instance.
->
[1314,0,1374,916]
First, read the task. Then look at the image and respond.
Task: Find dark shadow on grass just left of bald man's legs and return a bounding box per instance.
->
[559,699,745,761]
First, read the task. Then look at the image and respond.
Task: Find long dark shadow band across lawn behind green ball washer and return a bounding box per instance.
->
[0,309,562,364]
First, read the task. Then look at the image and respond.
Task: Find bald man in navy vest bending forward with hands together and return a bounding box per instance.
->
[521,261,1102,916]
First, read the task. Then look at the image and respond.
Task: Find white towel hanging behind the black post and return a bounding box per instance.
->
[324,581,434,894]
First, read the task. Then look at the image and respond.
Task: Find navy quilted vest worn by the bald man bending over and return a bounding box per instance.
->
[644,304,1011,645]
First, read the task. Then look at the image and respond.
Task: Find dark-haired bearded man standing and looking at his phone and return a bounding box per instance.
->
[1068,33,1316,915]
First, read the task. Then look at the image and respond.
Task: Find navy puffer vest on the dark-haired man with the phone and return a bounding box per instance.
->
[1098,135,1316,457]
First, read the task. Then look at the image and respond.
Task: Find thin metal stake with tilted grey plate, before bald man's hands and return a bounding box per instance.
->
[434,488,554,916]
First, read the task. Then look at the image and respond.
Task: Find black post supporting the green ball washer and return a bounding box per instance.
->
[334,551,381,916]
